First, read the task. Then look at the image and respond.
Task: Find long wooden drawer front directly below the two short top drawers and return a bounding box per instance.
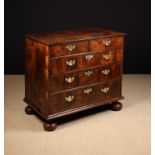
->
[50,49,122,74]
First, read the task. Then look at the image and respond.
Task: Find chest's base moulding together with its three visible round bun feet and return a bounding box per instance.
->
[24,96,124,131]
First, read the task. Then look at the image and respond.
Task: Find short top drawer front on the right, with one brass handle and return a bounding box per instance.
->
[90,37,123,51]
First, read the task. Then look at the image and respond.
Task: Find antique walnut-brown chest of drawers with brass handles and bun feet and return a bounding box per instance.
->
[24,28,125,131]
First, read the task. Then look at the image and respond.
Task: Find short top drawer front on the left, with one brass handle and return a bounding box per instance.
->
[51,41,89,57]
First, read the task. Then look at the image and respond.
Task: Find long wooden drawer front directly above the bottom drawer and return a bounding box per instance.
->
[50,64,121,93]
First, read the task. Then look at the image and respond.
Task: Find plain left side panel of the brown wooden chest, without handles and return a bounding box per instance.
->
[25,38,49,115]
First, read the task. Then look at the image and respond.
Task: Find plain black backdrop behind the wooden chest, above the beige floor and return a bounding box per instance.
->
[4,0,151,74]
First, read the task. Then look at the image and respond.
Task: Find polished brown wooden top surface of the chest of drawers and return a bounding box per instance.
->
[25,28,125,45]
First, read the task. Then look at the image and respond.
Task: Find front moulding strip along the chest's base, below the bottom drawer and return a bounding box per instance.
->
[47,96,124,121]
